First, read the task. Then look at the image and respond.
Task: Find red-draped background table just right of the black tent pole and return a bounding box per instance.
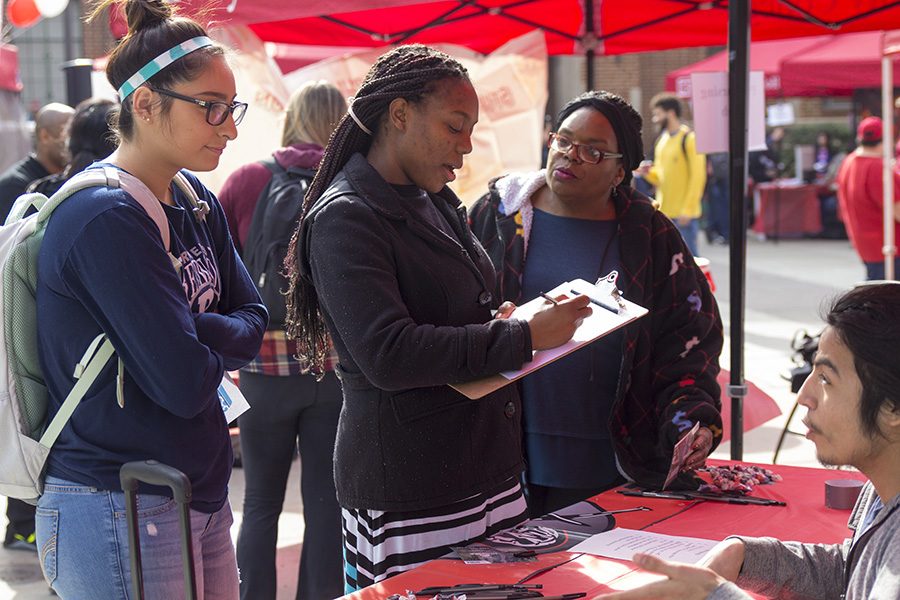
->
[753,181,822,239]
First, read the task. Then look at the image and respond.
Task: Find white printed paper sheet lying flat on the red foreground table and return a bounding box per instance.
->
[569,528,718,564]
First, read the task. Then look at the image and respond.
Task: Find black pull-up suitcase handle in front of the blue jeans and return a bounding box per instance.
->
[119,460,197,600]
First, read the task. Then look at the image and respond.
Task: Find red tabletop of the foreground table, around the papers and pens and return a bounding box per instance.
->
[345,460,865,600]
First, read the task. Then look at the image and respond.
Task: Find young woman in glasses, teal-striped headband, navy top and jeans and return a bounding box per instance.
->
[37,0,267,600]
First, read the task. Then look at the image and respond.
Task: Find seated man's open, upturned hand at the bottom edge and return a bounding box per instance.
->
[597,554,725,600]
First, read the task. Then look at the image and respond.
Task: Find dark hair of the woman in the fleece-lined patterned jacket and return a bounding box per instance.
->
[554,90,644,186]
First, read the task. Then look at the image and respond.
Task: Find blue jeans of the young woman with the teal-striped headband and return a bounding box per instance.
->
[36,477,238,600]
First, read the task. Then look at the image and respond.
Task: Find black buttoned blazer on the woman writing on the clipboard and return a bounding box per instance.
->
[297,154,531,511]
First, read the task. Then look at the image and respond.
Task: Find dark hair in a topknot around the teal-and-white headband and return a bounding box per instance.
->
[88,0,224,140]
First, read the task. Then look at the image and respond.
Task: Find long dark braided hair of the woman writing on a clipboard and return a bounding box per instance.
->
[284,44,469,377]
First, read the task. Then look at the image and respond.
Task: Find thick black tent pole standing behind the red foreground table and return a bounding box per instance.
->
[728,0,750,460]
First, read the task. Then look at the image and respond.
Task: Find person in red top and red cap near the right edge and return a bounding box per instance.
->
[838,117,900,280]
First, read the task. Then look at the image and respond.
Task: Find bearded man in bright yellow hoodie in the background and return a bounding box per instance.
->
[641,94,706,256]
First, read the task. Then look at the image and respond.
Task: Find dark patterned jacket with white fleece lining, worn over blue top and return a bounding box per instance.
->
[469,171,723,488]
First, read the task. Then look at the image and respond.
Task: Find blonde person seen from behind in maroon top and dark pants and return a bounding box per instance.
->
[219,81,347,600]
